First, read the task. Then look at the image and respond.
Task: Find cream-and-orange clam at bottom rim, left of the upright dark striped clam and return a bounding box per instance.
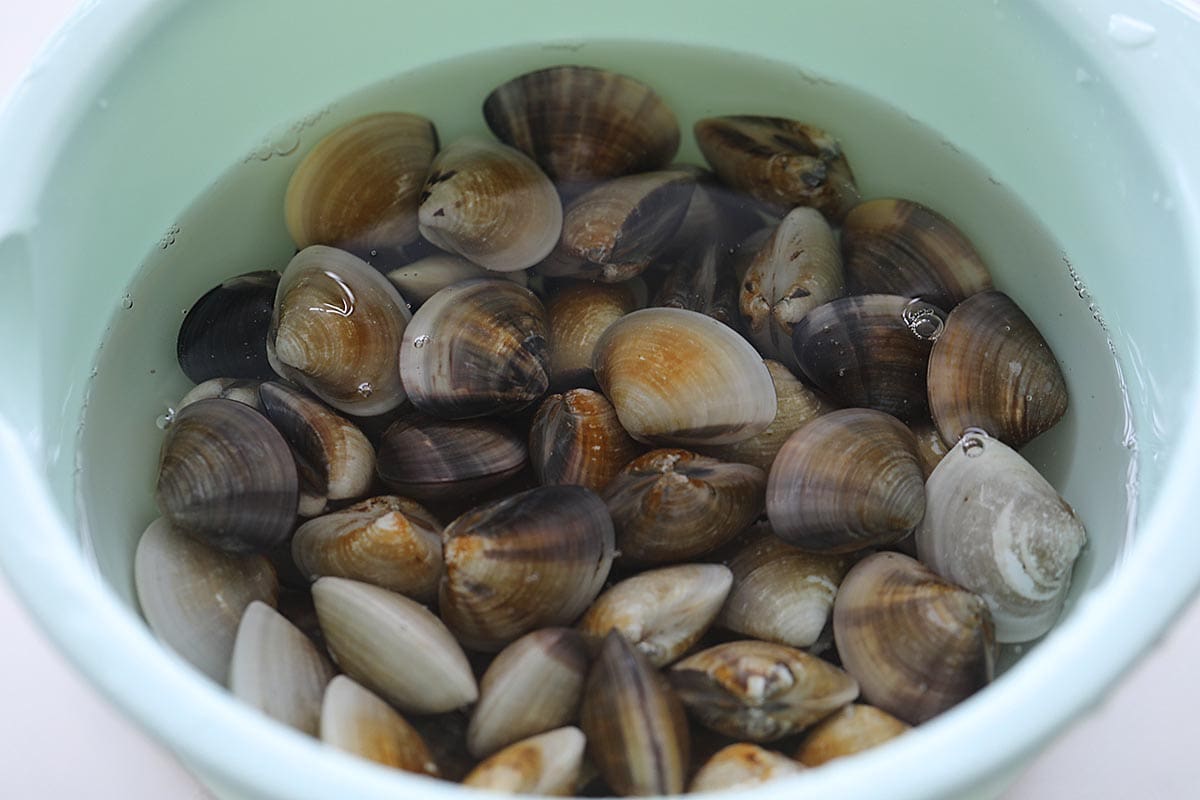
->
[462,727,587,798]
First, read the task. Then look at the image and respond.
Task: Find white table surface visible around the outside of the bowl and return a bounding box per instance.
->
[0,0,1200,800]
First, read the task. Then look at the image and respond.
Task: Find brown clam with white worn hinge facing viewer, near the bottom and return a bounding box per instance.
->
[667,640,858,742]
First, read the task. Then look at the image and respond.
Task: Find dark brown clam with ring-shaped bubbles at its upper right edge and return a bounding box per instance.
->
[792,295,950,420]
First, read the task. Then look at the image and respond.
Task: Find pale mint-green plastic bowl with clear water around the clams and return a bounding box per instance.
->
[0,0,1200,800]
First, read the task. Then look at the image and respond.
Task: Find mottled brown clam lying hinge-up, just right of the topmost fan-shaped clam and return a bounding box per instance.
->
[695,116,858,222]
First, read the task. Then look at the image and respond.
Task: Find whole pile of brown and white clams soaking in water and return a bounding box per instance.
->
[136,66,1085,795]
